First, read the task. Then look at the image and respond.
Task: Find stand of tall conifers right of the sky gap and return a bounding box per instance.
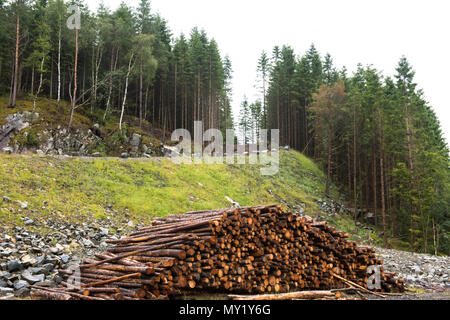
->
[238,45,450,254]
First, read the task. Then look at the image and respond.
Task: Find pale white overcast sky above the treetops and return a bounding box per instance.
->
[86,0,450,142]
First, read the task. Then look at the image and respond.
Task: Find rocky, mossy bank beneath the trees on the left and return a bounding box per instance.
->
[0,97,164,157]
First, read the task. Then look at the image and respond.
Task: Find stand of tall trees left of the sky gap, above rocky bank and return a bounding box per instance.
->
[0,0,233,132]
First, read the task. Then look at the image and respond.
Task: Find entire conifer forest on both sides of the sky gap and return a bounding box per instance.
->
[0,0,450,253]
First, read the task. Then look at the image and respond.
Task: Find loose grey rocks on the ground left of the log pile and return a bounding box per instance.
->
[0,218,139,299]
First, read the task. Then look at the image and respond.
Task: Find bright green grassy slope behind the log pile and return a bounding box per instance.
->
[0,151,382,245]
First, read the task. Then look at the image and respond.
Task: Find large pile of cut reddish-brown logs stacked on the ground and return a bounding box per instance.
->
[32,205,404,300]
